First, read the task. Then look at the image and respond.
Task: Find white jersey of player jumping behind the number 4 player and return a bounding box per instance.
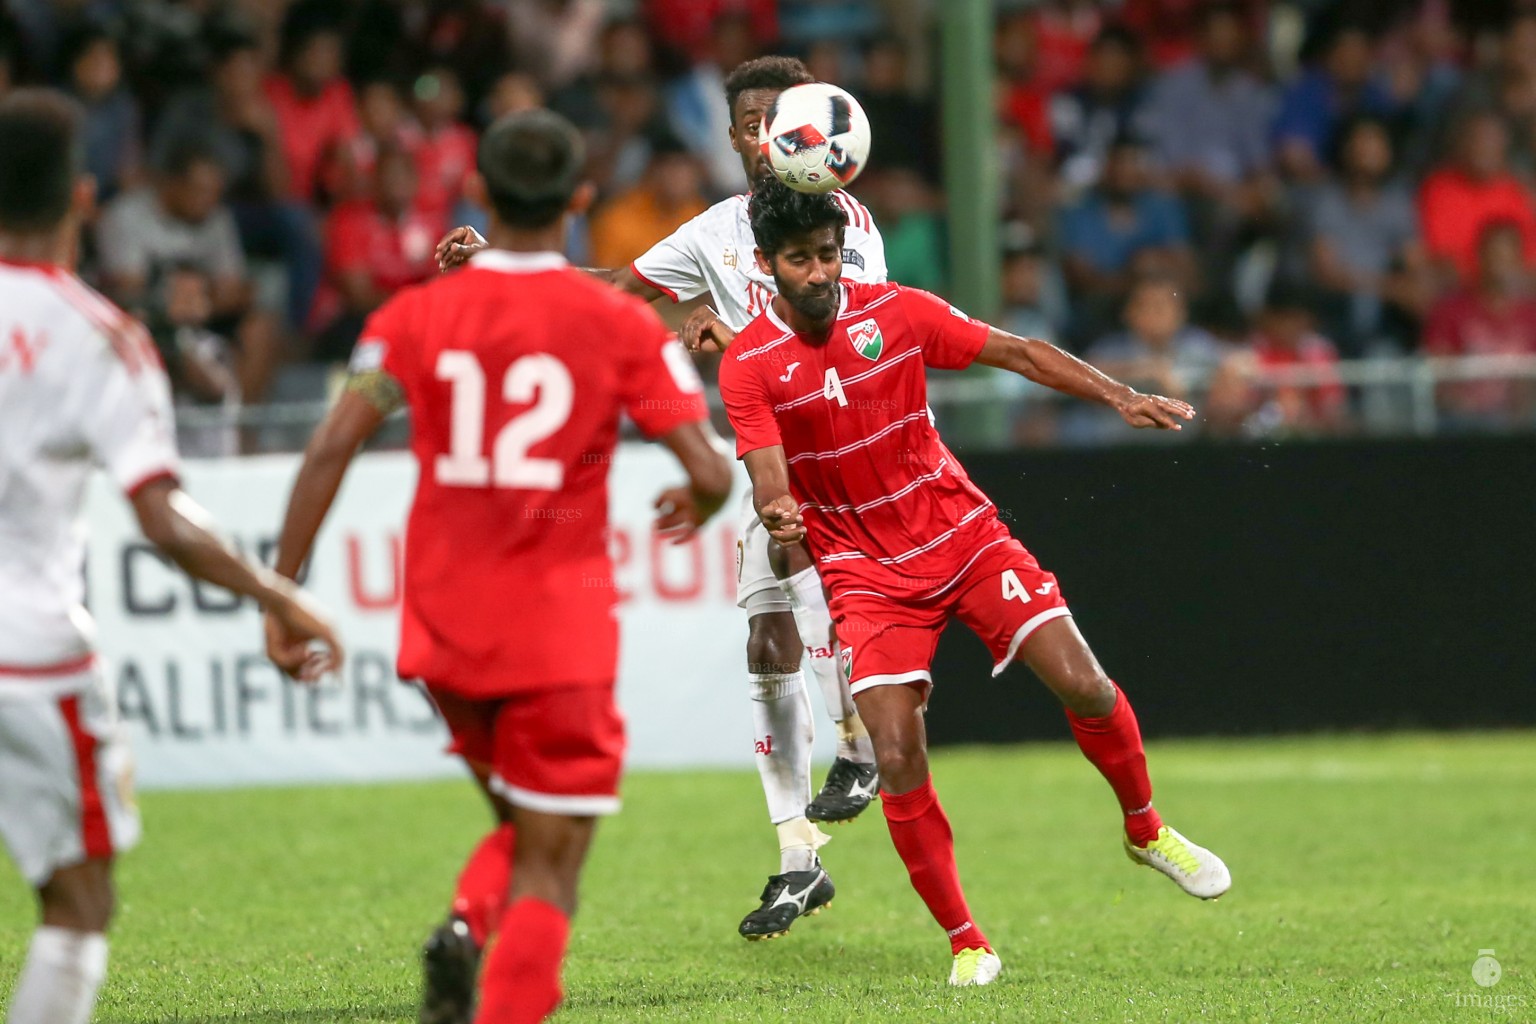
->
[630,190,886,330]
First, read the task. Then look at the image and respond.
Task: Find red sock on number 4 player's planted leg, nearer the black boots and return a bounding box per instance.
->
[880,775,992,953]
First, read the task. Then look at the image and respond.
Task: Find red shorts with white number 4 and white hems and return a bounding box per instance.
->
[831,537,1072,694]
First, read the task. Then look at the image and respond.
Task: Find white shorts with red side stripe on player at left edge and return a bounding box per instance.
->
[0,660,140,887]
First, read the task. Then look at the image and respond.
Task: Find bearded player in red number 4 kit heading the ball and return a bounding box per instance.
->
[720,181,1232,984]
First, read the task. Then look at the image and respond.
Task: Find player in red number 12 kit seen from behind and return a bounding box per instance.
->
[269,111,731,1024]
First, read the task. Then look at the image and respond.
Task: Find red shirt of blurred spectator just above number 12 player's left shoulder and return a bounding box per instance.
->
[326,200,447,292]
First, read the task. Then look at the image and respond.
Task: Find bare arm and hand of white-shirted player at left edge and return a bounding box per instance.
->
[131,477,344,682]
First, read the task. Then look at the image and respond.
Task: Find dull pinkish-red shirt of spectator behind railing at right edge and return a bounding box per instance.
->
[1424,292,1536,415]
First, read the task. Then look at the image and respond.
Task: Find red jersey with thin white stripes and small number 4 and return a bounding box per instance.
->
[720,282,1006,599]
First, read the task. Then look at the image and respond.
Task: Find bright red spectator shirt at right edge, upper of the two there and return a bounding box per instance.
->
[1419,167,1536,281]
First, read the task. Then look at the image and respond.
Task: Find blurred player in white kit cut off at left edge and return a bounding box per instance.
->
[0,89,341,1024]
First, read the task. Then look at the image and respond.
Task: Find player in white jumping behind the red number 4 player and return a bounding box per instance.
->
[438,57,886,940]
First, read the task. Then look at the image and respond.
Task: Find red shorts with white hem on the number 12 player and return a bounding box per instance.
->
[427,683,624,817]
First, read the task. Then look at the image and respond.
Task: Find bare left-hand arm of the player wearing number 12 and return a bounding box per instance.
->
[266,388,387,676]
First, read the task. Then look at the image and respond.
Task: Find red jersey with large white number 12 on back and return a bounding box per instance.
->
[352,250,707,697]
